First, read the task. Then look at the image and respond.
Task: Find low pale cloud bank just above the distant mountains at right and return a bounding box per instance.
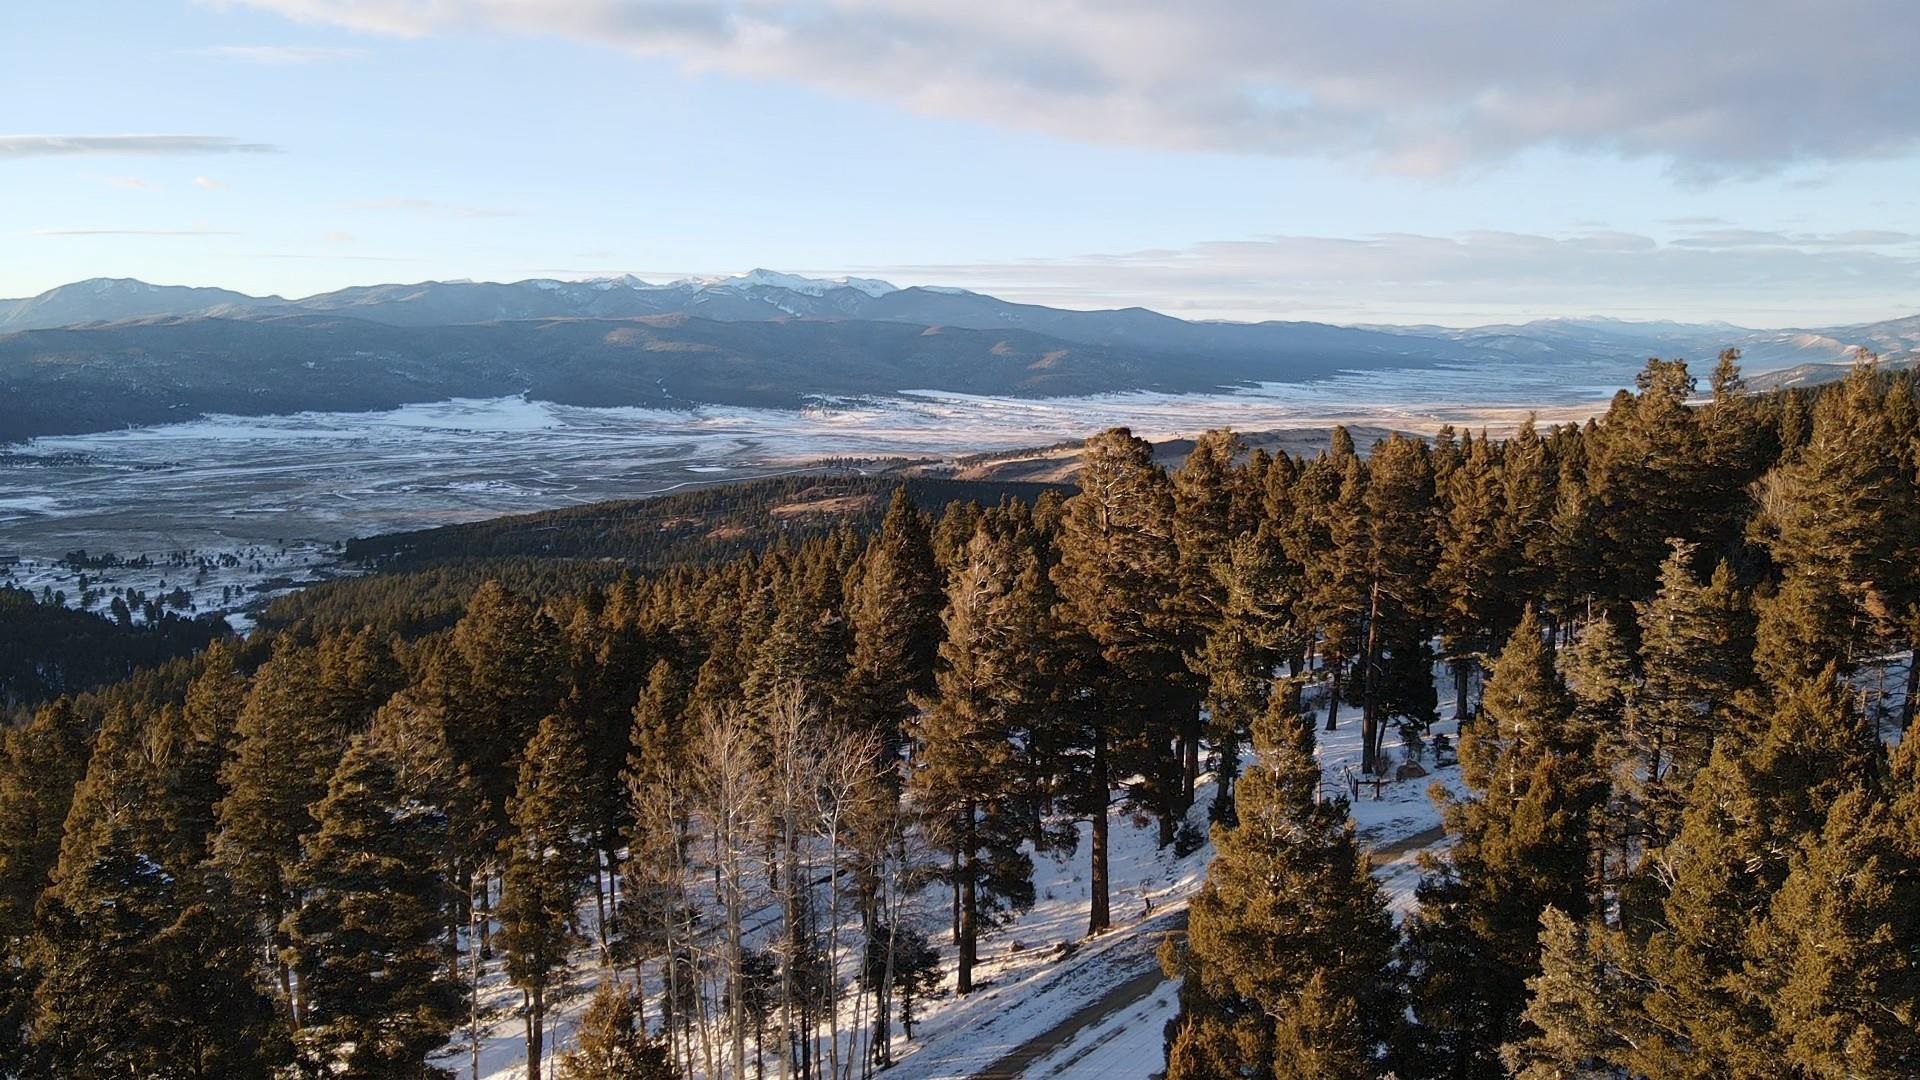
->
[875,231,1920,325]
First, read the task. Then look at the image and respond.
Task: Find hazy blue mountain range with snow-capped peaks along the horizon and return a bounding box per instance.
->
[0,271,1920,440]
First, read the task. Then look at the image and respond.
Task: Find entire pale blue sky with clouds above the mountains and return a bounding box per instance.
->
[0,0,1920,327]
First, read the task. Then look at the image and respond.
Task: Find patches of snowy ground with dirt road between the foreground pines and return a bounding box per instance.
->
[440,664,1463,1080]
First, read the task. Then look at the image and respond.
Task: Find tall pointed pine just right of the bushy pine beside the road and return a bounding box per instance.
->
[1405,609,1605,1076]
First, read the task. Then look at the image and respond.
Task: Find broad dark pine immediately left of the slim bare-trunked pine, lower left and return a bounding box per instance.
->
[284,736,461,1078]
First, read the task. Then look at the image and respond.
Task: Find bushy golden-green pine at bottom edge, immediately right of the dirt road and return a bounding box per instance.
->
[1162,688,1400,1080]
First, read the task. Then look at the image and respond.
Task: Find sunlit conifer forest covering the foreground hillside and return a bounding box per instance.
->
[0,356,1920,1080]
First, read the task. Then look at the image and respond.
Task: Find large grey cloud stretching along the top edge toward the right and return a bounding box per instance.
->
[223,0,1920,179]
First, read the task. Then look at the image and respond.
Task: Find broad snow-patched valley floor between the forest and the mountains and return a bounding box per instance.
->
[0,345,1681,595]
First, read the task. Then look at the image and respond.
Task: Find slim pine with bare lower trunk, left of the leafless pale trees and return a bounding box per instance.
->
[499,715,593,1080]
